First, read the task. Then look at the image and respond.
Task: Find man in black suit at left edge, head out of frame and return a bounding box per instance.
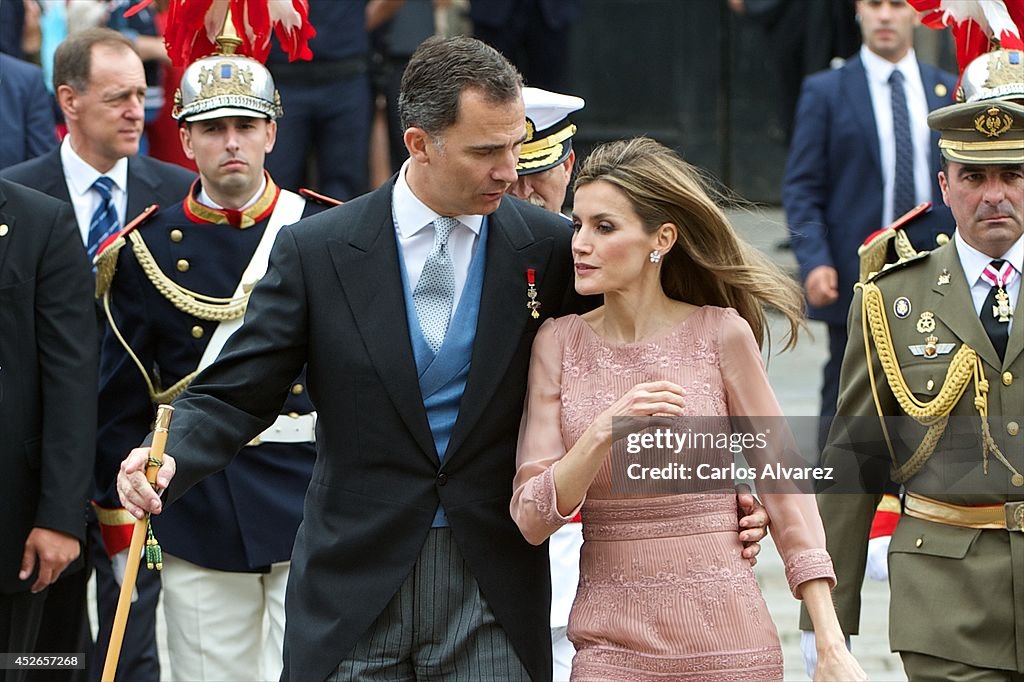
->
[0,179,96,680]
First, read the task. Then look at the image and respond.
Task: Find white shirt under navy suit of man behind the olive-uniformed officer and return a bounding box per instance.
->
[860,45,936,229]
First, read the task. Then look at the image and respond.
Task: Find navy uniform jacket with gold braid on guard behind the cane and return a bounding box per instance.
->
[91,174,329,667]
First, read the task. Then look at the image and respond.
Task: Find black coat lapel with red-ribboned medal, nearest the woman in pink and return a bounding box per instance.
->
[444,201,554,464]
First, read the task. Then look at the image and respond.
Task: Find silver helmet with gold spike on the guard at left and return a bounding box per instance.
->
[171,14,285,123]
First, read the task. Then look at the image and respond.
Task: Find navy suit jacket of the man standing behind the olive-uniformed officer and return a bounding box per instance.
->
[782,56,956,326]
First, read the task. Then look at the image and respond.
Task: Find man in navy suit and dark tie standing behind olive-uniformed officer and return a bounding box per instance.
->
[782,0,955,454]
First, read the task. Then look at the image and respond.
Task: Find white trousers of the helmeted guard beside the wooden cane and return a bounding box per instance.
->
[161,554,290,682]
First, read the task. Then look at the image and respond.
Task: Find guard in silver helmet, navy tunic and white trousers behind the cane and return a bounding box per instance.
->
[96,11,336,680]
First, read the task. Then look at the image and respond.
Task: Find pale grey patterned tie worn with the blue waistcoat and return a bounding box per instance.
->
[413,216,459,353]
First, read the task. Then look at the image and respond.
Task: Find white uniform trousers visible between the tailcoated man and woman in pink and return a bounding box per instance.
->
[548,523,583,682]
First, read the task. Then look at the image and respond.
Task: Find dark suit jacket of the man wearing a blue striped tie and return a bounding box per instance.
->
[0,146,196,227]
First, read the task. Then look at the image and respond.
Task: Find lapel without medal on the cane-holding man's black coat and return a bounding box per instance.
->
[328,179,437,462]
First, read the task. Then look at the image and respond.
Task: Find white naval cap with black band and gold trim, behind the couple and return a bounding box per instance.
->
[516,87,585,175]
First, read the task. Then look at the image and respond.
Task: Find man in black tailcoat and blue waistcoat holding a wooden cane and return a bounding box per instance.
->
[118,37,572,680]
